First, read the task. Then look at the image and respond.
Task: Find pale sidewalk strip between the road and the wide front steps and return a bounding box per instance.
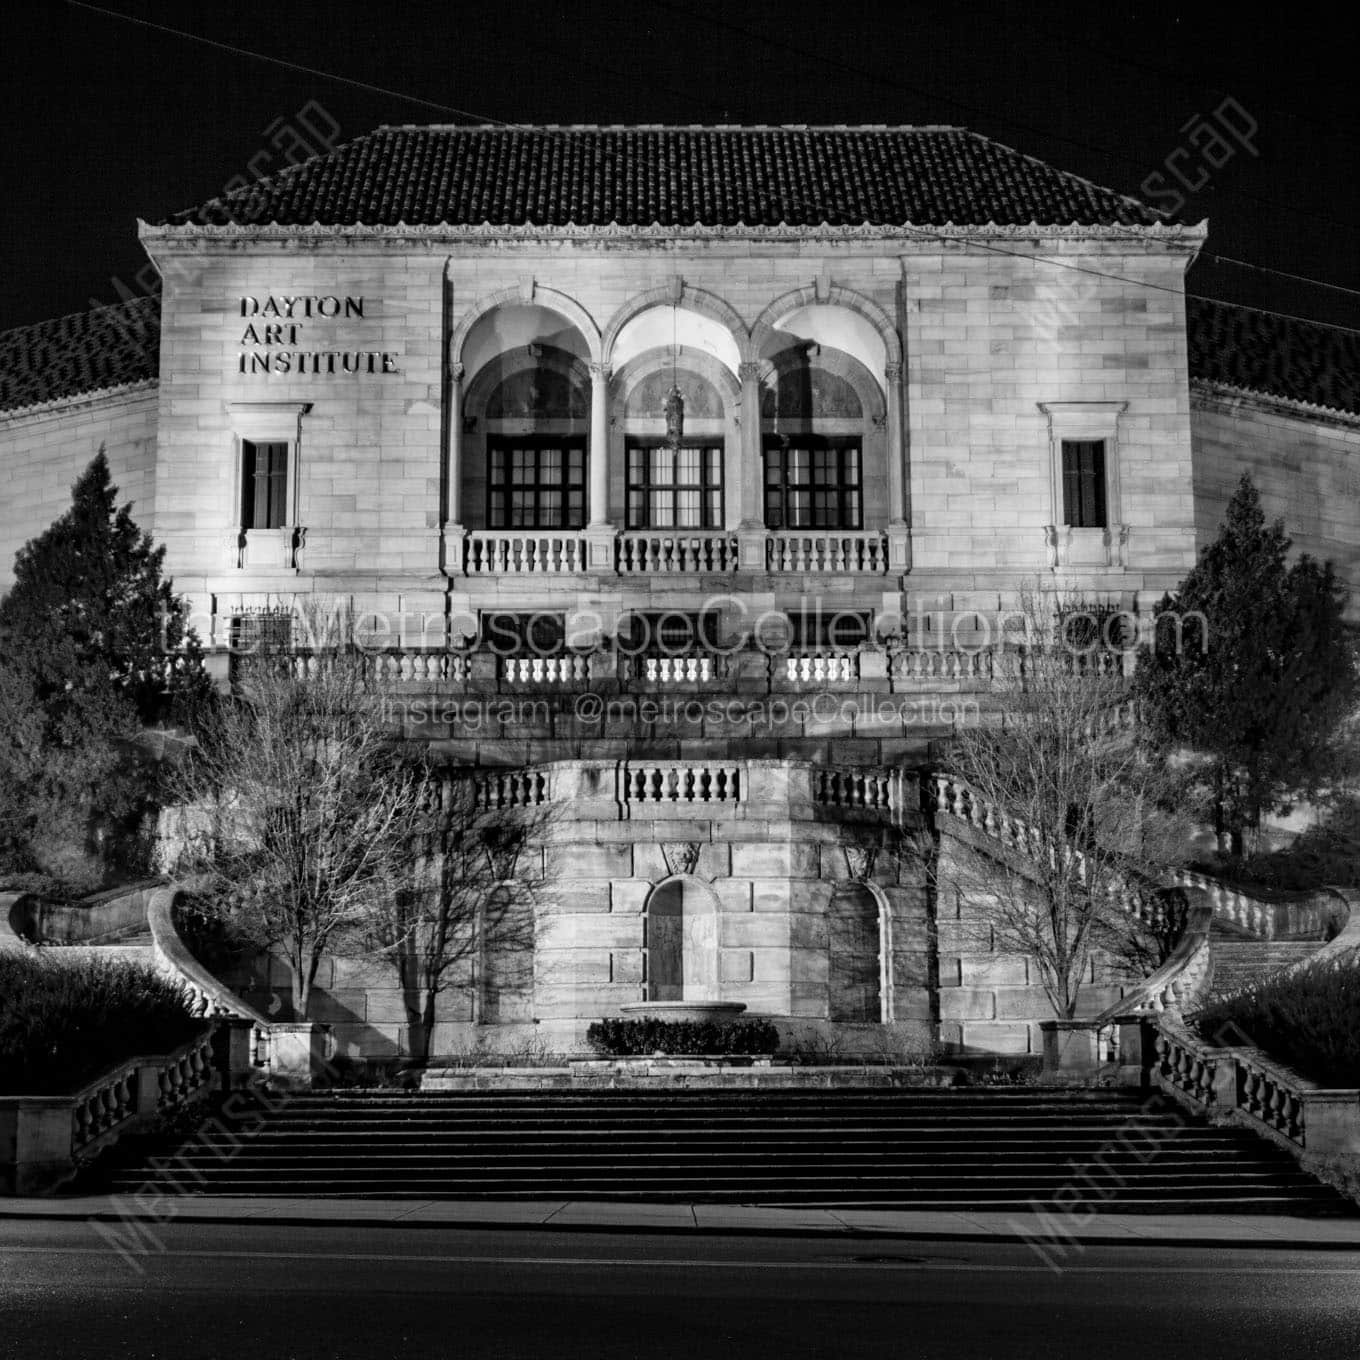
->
[0,1195,1360,1251]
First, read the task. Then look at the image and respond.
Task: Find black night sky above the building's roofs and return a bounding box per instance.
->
[0,0,1360,328]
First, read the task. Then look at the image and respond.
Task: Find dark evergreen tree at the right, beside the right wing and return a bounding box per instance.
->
[1136,476,1357,854]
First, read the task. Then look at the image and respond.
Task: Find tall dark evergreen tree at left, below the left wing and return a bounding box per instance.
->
[0,447,211,891]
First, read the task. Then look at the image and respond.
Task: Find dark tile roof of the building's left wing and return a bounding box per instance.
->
[0,298,160,411]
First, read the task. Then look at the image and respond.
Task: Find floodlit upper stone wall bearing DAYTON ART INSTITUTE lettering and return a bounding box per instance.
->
[135,238,1194,642]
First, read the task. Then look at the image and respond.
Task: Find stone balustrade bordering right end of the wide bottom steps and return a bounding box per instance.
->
[1152,1019,1360,1161]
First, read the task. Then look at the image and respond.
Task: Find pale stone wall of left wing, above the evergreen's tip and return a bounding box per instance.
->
[0,388,156,592]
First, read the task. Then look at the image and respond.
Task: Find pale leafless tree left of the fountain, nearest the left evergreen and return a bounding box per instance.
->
[177,615,427,1019]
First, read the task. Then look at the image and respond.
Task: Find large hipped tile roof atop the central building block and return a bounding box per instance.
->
[169,126,1167,227]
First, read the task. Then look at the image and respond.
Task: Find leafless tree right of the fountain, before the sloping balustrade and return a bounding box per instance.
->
[948,585,1178,1019]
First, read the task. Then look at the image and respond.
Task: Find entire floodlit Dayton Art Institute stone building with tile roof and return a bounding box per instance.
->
[0,128,1360,1050]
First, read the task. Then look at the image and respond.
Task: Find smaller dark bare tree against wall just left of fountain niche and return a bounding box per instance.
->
[370,770,549,1062]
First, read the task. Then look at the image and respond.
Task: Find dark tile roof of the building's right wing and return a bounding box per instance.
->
[1186,298,1360,415]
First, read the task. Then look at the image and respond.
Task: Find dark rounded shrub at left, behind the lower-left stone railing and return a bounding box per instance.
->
[0,953,204,1096]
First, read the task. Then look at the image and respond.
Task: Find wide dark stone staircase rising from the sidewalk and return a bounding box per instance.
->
[91,1088,1346,1213]
